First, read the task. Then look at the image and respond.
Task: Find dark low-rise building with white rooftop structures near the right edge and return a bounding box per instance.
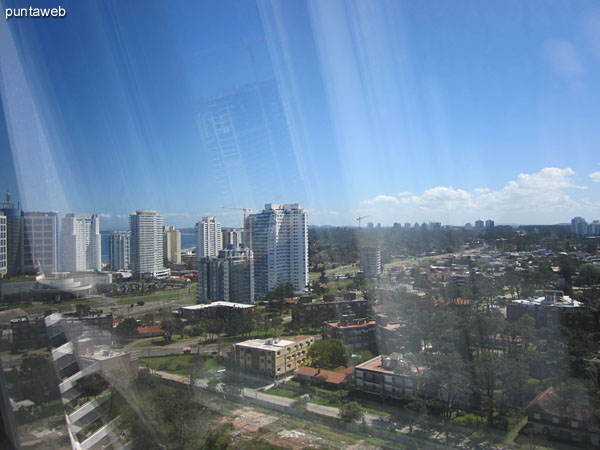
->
[506,291,599,332]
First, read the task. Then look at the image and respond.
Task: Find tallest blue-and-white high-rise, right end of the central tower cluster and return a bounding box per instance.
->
[245,203,308,298]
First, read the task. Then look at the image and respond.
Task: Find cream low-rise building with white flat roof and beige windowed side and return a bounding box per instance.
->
[234,336,315,379]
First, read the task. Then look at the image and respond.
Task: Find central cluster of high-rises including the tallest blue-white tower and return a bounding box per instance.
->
[196,203,308,303]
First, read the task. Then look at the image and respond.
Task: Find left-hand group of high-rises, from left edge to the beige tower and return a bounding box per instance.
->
[0,193,181,278]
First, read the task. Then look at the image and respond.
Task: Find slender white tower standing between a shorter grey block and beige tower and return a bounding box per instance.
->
[129,211,170,278]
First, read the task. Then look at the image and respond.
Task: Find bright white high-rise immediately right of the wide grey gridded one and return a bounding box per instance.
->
[60,214,102,272]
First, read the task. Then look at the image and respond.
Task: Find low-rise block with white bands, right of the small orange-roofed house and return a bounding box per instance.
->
[354,353,427,399]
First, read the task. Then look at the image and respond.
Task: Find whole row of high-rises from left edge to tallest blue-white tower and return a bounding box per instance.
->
[0,190,308,303]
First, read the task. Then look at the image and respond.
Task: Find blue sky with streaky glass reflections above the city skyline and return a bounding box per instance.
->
[0,0,600,229]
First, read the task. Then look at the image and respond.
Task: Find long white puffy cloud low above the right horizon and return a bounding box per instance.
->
[361,167,584,224]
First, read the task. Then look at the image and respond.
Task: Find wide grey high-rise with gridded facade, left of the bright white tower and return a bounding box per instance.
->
[21,212,58,275]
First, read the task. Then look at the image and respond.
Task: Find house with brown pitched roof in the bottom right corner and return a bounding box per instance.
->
[525,387,600,447]
